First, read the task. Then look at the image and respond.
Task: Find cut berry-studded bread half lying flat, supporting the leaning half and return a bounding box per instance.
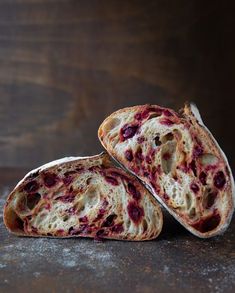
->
[4,153,163,240]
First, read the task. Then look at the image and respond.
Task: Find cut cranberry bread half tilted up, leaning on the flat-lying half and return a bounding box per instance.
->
[98,104,234,238]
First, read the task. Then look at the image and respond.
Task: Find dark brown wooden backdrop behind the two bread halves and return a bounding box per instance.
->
[0,0,235,167]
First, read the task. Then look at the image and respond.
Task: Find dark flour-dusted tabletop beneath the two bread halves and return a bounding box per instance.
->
[0,168,235,293]
